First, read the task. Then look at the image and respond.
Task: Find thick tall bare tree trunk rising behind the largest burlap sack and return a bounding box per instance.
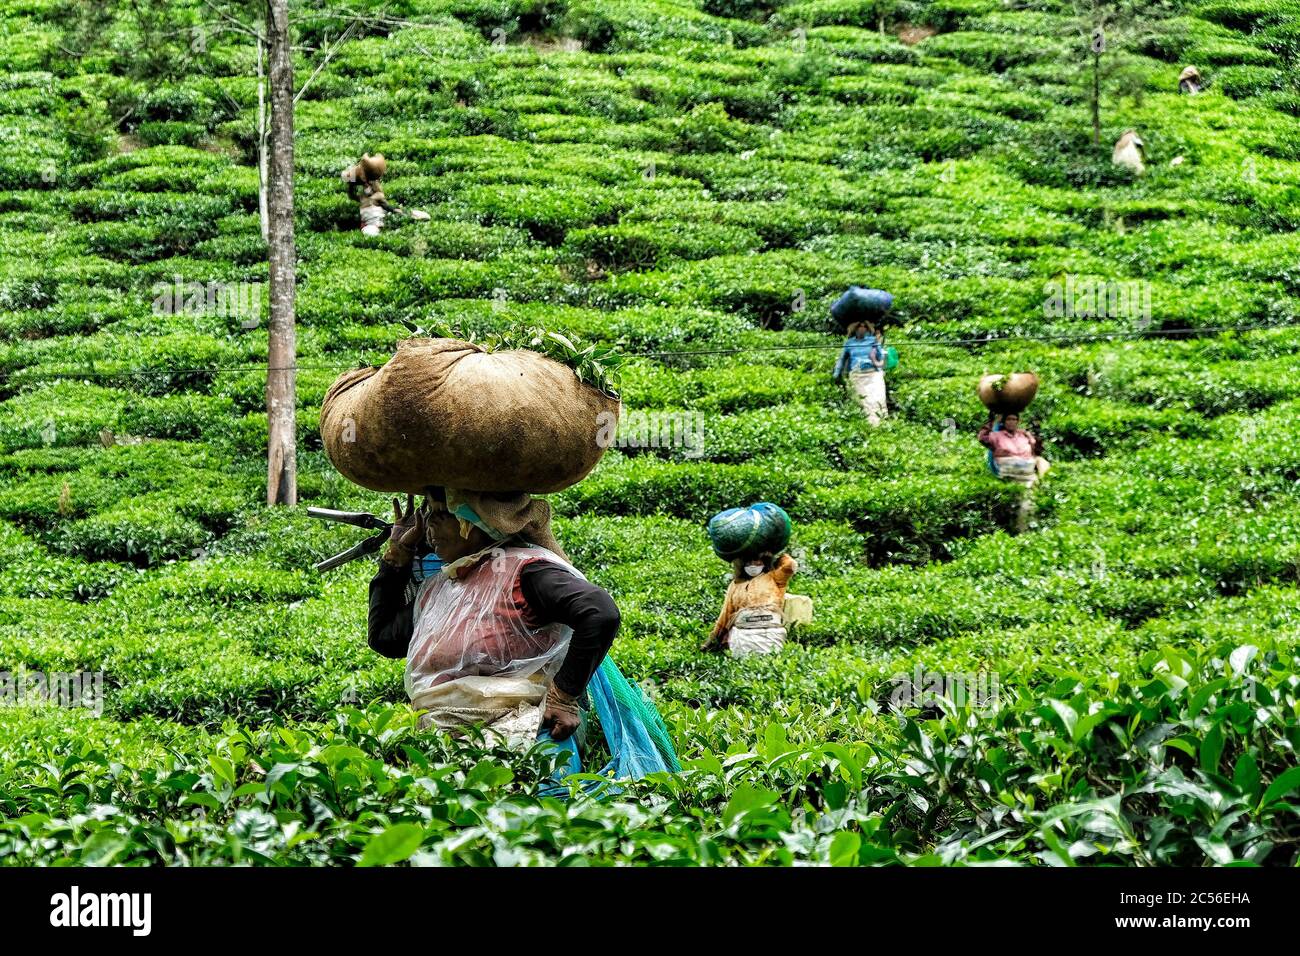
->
[267,0,298,505]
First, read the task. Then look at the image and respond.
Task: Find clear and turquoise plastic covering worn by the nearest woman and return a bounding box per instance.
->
[406,545,681,792]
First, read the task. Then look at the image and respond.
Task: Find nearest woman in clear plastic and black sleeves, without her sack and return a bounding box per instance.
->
[368,488,677,777]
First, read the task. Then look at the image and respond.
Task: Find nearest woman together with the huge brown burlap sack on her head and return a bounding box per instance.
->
[330,338,679,792]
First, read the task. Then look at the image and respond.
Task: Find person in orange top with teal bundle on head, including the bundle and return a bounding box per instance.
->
[701,502,798,657]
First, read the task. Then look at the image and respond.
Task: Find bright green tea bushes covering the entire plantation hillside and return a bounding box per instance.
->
[0,0,1300,865]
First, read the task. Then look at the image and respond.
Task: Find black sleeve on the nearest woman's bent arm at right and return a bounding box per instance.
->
[519,561,620,697]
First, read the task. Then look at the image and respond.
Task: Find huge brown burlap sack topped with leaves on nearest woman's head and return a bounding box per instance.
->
[321,338,619,494]
